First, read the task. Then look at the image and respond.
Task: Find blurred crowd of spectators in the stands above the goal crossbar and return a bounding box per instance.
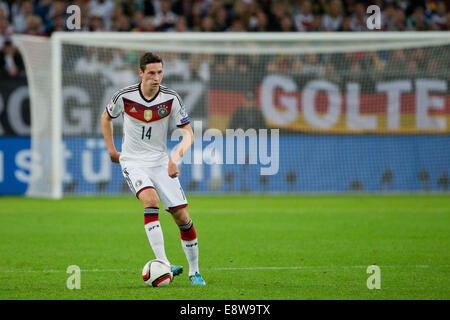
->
[0,0,450,76]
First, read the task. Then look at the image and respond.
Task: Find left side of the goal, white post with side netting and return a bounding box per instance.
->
[14,35,63,199]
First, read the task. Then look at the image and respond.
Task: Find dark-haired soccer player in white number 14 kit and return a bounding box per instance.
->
[101,52,206,285]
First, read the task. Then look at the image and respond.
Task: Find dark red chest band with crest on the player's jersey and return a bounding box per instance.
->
[123,98,173,123]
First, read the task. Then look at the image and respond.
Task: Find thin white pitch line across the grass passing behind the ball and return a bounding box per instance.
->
[0,265,442,273]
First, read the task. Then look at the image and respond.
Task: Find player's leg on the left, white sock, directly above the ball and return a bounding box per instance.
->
[122,168,169,262]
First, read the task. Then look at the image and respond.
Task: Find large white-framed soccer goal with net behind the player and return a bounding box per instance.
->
[15,32,450,198]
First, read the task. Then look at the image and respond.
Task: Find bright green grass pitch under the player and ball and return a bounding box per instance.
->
[0,194,450,300]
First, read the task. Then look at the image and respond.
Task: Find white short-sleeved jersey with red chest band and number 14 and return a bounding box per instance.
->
[106,83,189,167]
